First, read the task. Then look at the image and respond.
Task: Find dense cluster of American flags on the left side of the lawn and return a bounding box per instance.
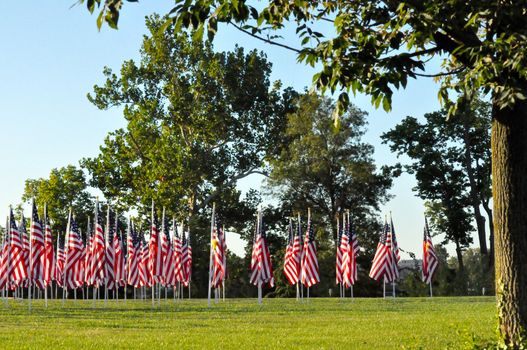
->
[0,202,192,290]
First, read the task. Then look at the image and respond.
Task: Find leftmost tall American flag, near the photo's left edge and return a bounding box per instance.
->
[8,210,27,288]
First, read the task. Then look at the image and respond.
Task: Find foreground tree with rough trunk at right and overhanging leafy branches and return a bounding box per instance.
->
[87,0,527,347]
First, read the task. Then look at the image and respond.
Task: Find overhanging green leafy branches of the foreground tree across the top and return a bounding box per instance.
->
[81,0,527,114]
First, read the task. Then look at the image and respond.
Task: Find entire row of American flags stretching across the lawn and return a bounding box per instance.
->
[0,202,438,296]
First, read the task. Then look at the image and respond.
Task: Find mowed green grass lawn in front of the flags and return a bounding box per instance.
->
[0,297,496,350]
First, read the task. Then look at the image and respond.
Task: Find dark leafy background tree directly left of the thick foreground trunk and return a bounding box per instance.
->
[381,99,493,270]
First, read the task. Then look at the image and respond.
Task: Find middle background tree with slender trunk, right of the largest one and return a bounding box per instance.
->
[268,94,392,295]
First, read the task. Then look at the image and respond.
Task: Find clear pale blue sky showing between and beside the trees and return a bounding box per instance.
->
[0,0,462,256]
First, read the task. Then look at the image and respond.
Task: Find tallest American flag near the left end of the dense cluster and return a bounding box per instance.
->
[30,201,46,289]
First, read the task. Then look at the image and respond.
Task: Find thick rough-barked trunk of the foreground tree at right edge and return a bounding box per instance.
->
[492,101,527,347]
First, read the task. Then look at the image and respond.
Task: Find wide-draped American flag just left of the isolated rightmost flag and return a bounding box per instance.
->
[370,222,395,282]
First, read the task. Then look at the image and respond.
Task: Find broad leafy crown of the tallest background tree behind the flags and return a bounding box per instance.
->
[82,16,295,221]
